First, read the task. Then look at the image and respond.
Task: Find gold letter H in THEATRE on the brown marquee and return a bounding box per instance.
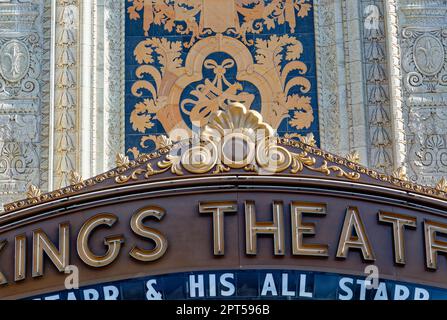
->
[245,201,285,255]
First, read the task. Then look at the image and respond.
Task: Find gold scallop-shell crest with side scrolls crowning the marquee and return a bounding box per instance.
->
[116,102,360,183]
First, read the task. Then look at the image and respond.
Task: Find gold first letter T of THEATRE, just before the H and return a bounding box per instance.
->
[199,201,237,256]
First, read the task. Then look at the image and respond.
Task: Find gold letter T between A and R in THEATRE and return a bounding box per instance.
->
[379,211,416,264]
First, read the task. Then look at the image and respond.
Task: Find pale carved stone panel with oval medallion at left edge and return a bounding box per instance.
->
[0,0,43,208]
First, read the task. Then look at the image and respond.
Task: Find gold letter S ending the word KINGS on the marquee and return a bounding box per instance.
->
[129,206,168,261]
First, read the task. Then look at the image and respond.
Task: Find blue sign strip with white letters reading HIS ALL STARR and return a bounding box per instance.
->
[30,270,447,300]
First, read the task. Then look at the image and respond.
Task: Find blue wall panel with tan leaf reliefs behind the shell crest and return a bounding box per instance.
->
[126,0,319,157]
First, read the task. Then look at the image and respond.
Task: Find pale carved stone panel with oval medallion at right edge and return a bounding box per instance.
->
[401,0,447,185]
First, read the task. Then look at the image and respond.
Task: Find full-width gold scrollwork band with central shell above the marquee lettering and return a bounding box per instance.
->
[4,103,447,212]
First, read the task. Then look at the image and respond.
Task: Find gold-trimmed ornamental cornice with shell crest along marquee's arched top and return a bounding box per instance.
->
[5,105,447,212]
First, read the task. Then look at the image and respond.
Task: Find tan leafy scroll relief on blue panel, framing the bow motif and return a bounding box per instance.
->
[130,35,314,143]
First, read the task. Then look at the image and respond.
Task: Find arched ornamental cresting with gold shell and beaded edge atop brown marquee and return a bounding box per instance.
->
[5,103,447,215]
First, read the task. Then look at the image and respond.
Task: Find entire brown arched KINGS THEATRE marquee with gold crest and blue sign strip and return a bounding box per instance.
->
[0,104,447,300]
